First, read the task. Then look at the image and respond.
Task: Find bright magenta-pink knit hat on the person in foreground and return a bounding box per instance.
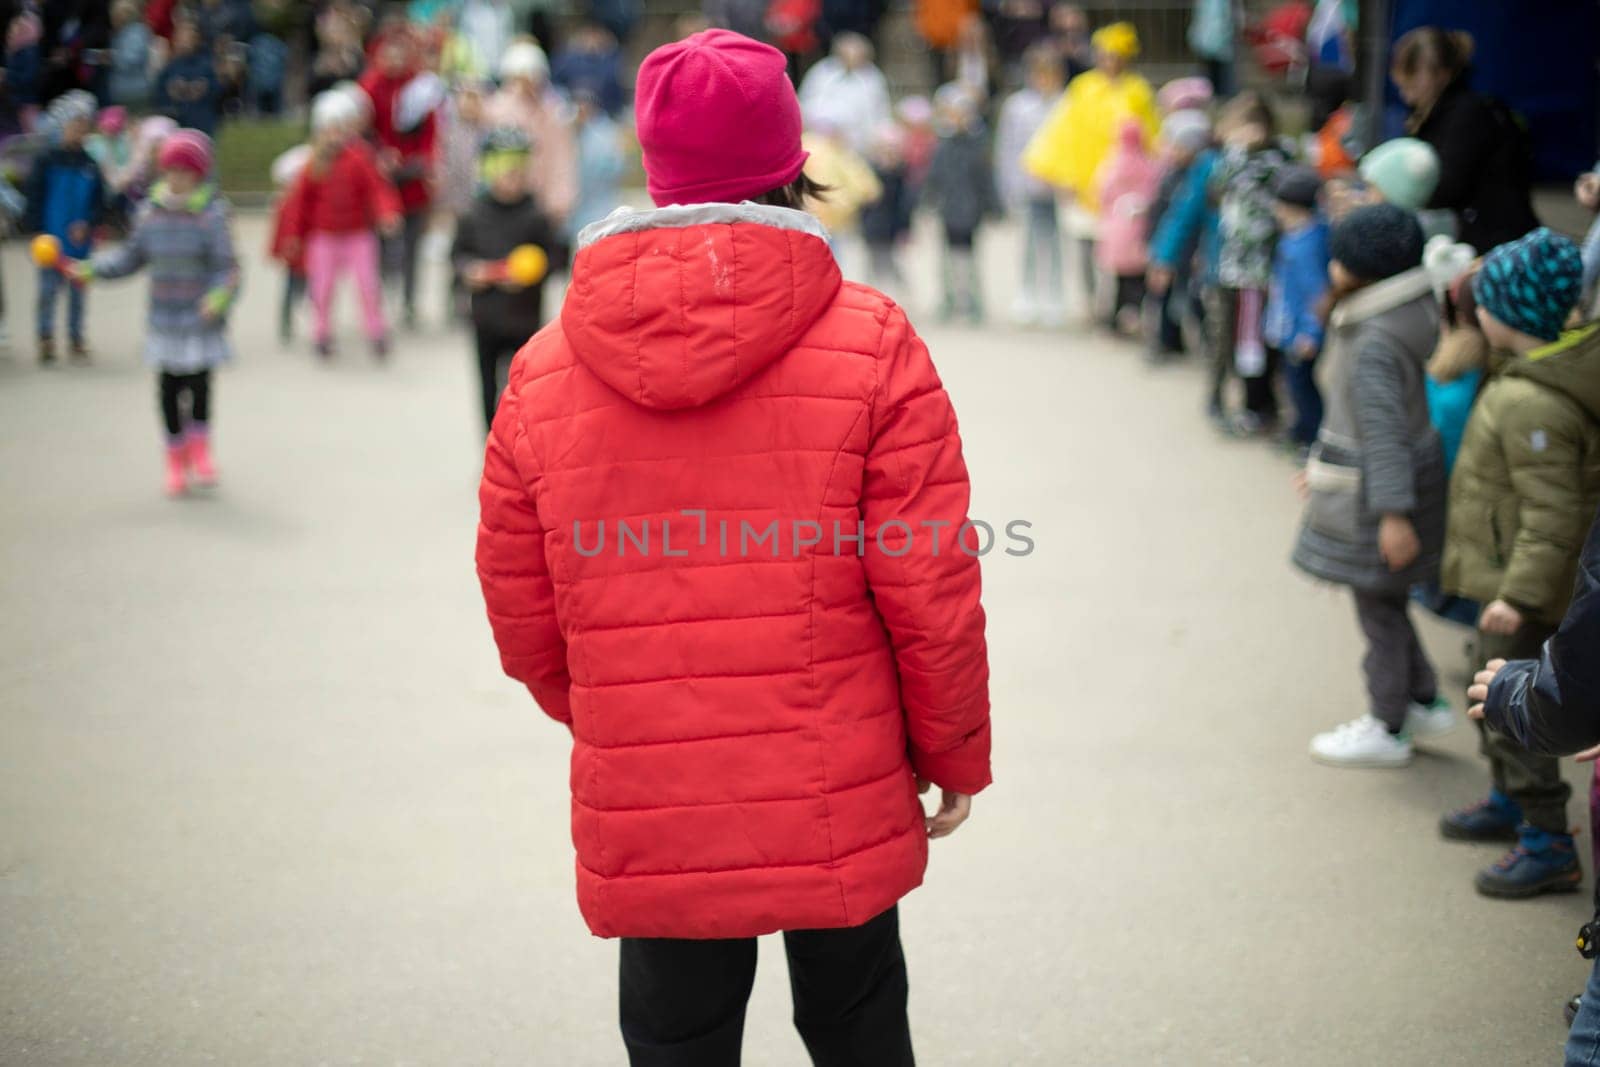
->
[634,30,806,206]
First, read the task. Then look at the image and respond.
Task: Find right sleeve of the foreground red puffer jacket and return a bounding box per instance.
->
[861,310,990,793]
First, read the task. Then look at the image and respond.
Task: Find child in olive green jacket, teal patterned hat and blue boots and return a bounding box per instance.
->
[1440,229,1600,897]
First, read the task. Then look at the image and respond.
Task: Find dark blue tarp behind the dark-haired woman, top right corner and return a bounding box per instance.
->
[1386,0,1600,179]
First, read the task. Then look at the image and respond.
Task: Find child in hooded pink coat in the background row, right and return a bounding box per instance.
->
[1094,118,1162,333]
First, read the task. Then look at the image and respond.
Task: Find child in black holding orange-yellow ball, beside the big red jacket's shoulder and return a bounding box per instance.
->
[450,128,565,429]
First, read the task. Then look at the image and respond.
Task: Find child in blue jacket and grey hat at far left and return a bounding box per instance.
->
[22,90,106,363]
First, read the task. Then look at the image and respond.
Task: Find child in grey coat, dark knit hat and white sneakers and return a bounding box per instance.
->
[1294,203,1456,766]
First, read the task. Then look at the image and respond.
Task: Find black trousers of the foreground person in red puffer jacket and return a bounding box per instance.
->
[621,907,915,1067]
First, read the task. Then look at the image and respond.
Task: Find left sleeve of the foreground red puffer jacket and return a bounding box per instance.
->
[477,362,573,728]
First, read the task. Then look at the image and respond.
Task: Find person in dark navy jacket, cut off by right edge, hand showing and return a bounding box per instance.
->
[1467,515,1600,1064]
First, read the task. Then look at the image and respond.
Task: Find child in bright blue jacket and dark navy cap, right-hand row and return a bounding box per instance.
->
[1261,166,1328,450]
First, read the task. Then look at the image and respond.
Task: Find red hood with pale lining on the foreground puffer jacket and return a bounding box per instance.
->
[562,203,840,411]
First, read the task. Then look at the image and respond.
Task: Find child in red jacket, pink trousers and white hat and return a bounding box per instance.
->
[274,94,400,358]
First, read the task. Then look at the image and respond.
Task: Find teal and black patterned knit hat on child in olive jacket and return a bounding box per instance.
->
[1472,226,1584,341]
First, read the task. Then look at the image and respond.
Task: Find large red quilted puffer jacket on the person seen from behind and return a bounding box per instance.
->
[477,205,989,937]
